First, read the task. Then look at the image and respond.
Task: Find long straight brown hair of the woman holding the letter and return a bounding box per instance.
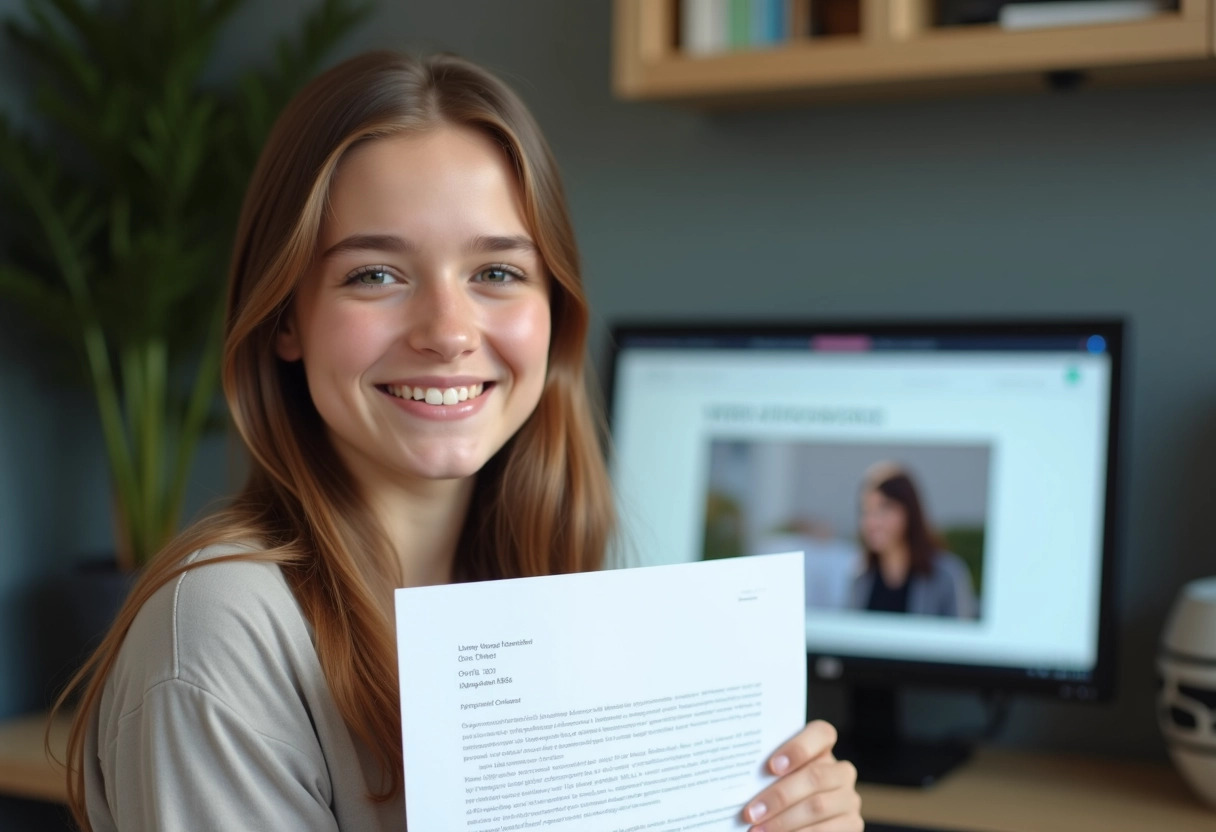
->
[56,52,614,830]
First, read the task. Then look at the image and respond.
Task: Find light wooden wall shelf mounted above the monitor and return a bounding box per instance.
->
[614,0,1216,102]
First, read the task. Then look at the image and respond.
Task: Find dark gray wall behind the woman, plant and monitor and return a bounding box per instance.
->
[0,0,1216,778]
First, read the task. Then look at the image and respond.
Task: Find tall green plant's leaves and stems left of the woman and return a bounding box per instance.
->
[0,0,368,570]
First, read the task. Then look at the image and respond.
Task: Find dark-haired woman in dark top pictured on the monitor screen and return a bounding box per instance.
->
[852,462,976,618]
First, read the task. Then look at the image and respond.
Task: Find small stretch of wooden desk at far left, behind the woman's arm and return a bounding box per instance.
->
[0,714,72,803]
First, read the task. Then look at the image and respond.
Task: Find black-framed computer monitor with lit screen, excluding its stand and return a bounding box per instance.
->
[610,321,1122,699]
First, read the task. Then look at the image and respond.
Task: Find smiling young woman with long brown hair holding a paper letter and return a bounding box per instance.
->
[59,54,861,832]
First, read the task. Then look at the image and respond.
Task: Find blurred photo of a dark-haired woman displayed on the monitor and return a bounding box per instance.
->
[702,438,991,620]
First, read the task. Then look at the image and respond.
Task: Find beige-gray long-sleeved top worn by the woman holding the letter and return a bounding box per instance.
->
[85,547,405,832]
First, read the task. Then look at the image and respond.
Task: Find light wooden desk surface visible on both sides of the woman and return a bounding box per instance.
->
[0,714,1216,832]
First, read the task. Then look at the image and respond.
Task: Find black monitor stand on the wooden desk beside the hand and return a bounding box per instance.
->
[835,687,972,788]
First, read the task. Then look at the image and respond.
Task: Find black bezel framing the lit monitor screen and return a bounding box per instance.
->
[604,317,1127,702]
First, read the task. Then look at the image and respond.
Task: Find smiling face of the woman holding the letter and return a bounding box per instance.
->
[277,127,550,487]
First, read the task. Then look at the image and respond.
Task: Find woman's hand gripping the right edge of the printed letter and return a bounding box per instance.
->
[743,721,865,832]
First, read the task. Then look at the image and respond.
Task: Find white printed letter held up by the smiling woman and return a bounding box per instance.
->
[396,553,806,832]
